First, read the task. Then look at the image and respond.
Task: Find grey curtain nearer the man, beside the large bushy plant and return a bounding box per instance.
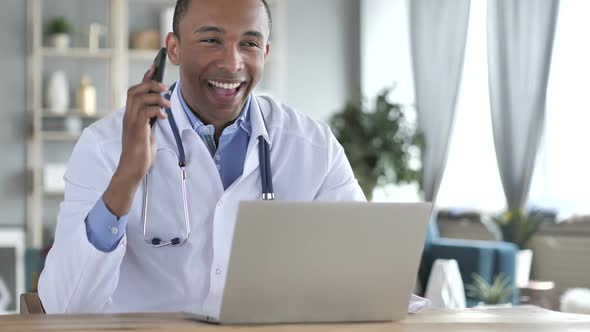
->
[409,0,470,202]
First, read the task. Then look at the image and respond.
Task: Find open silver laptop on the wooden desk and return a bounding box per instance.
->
[186,201,432,324]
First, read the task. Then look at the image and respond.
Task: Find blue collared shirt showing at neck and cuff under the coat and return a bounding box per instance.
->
[85,81,252,252]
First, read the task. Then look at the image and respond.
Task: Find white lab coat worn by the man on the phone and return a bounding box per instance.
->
[38,84,365,316]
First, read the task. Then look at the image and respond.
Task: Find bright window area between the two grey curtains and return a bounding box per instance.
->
[437,1,505,212]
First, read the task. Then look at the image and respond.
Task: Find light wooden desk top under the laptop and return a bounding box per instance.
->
[0,307,590,332]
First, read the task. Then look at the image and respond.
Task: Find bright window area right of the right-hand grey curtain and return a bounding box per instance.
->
[529,0,590,217]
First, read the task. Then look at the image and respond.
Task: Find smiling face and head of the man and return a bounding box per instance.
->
[167,0,270,126]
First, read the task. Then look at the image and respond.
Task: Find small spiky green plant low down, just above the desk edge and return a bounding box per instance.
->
[465,273,512,306]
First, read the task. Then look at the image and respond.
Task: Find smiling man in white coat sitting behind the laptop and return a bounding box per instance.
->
[39,0,365,316]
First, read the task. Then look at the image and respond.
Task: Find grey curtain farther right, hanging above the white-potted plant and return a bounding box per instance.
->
[488,0,559,209]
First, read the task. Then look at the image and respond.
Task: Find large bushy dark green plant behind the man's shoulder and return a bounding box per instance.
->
[330,88,424,200]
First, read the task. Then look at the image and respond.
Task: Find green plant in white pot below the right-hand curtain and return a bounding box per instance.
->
[492,209,555,287]
